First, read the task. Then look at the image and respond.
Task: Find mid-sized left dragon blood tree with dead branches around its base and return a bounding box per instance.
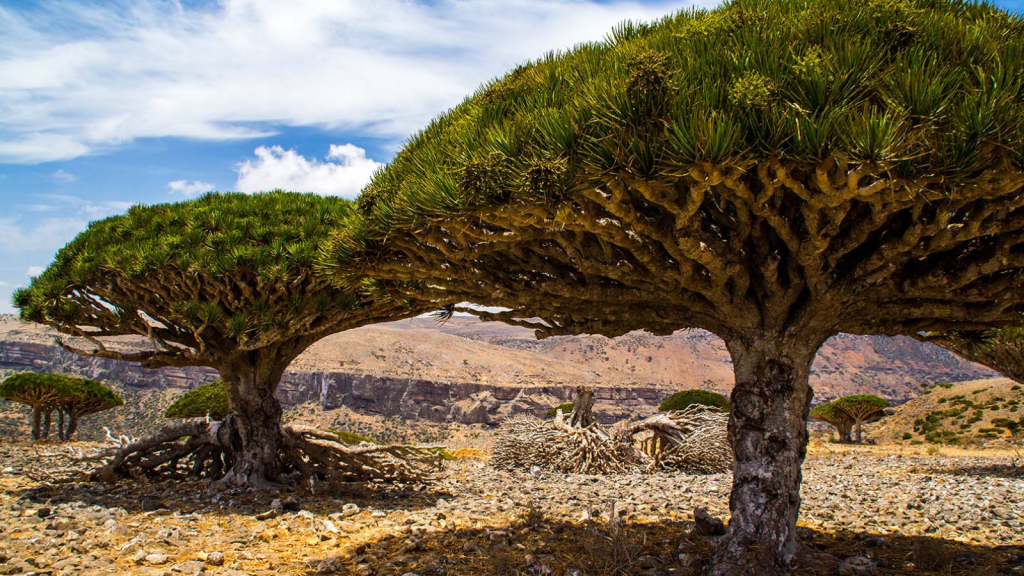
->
[14,192,434,487]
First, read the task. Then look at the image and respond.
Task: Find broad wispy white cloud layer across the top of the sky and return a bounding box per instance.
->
[0,0,708,163]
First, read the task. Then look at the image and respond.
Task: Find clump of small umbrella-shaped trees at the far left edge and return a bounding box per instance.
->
[0,372,124,442]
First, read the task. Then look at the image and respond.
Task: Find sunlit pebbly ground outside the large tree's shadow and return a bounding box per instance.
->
[0,443,1024,576]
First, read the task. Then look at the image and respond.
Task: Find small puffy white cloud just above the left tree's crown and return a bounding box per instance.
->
[234,143,381,198]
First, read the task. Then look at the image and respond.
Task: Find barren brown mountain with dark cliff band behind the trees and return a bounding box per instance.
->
[0,316,993,436]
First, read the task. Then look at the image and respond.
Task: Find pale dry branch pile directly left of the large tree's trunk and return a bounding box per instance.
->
[616,404,733,474]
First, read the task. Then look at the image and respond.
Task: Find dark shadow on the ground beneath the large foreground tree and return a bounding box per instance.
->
[309,510,1024,576]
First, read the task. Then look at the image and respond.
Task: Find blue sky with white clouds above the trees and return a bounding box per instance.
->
[0,0,1024,313]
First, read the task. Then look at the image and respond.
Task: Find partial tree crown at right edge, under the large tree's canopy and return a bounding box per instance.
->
[916,328,1024,383]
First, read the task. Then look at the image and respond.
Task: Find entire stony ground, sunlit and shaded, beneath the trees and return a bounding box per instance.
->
[0,436,1024,576]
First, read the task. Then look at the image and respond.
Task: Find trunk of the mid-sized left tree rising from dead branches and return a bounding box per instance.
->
[220,351,294,489]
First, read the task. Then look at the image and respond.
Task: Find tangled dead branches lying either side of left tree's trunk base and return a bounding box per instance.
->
[82,419,441,488]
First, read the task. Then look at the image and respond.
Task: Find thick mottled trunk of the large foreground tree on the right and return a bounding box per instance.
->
[708,336,821,576]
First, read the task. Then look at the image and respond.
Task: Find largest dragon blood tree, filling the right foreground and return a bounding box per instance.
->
[322,0,1024,574]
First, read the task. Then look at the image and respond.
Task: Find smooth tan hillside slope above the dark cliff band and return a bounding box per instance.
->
[0,316,995,403]
